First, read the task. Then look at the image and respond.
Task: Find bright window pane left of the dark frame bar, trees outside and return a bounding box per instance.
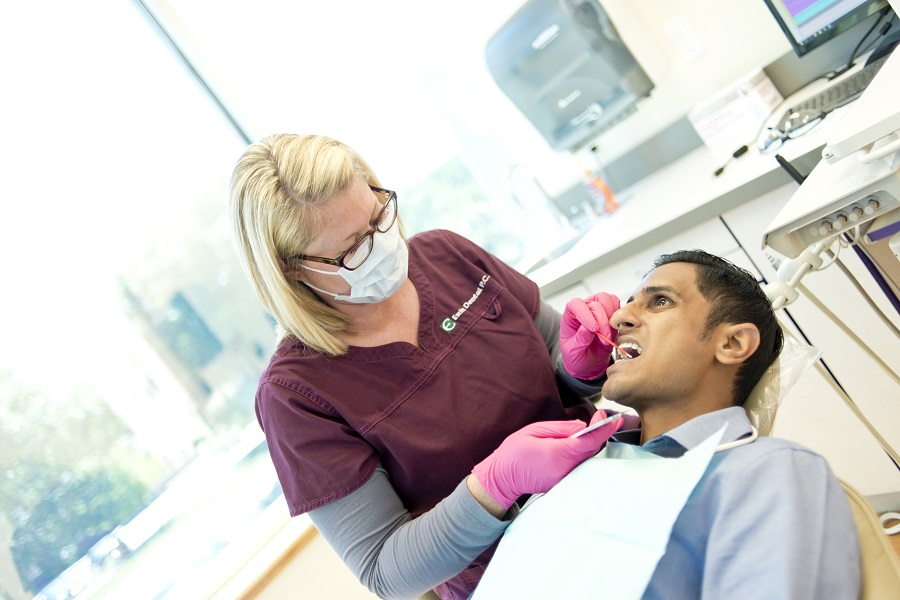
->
[0,0,283,600]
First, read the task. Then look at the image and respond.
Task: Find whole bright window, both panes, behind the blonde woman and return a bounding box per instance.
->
[0,0,584,600]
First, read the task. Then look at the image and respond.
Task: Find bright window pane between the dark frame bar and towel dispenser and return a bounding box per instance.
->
[159,0,581,265]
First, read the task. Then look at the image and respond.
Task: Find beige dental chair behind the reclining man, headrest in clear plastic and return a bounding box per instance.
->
[744,339,900,600]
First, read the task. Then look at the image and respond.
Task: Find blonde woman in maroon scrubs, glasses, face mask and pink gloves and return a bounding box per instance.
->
[231,135,622,599]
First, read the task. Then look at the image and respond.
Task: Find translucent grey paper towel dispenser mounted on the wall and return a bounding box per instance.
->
[485,0,653,150]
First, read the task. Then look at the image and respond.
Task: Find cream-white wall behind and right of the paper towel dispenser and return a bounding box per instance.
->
[486,0,791,194]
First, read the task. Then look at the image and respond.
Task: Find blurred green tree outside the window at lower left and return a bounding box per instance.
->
[0,371,162,592]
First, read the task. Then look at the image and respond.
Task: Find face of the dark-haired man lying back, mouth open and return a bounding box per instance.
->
[603,263,716,411]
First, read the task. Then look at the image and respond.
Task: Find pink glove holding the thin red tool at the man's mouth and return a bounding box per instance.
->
[559,292,619,380]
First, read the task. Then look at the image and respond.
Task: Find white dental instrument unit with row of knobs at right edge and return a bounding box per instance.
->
[762,47,900,464]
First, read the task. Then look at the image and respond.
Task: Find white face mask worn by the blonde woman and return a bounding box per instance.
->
[301,221,409,304]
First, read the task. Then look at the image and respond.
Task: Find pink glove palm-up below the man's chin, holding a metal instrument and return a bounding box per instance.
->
[472,410,623,510]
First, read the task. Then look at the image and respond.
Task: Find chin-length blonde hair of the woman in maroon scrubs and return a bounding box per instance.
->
[231,134,381,356]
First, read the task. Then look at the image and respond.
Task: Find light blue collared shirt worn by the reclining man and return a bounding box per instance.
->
[613,407,860,600]
